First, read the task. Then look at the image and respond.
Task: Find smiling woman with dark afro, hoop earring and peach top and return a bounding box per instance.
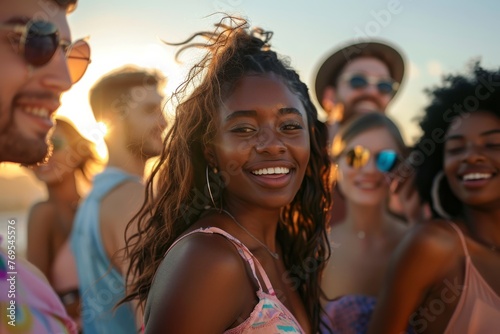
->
[369,64,500,334]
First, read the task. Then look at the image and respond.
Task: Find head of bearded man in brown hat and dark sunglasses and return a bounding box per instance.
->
[315,41,405,139]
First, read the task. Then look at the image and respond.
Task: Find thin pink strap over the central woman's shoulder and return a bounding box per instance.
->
[167,227,275,296]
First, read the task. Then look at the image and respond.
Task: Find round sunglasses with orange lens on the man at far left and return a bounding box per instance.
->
[0,21,90,83]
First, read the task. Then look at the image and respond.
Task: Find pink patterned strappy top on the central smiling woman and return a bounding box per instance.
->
[155,227,305,334]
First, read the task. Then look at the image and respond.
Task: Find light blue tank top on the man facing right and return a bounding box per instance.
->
[71,167,140,334]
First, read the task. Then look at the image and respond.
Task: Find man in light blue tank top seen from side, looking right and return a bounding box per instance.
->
[71,66,167,334]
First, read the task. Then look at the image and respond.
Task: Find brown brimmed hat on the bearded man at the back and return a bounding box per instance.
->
[314,40,405,105]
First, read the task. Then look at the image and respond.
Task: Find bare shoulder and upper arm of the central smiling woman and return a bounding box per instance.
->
[145,233,255,332]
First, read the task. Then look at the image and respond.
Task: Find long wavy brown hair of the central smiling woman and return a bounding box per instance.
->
[123,17,331,332]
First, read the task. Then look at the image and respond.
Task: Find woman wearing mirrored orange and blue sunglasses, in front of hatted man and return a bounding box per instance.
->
[322,113,414,333]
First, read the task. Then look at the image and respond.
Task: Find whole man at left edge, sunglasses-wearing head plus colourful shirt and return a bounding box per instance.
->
[0,0,90,334]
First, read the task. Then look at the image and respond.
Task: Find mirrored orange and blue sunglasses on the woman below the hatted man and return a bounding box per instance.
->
[345,145,399,173]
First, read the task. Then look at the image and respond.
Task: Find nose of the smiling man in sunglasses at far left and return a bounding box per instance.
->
[39,49,73,94]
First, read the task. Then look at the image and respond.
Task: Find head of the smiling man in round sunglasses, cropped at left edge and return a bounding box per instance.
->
[0,0,90,165]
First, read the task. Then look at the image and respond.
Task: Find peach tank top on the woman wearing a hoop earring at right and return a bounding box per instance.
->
[445,223,500,334]
